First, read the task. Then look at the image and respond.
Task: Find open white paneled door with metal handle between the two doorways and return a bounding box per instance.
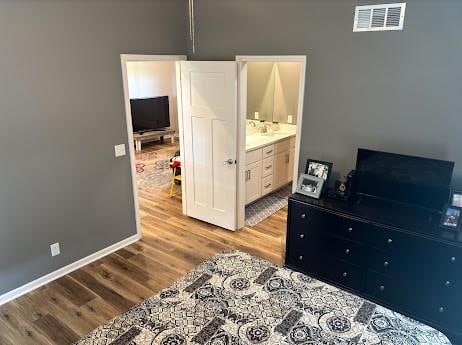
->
[180,61,237,230]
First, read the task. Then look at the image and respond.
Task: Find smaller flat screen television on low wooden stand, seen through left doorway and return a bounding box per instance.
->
[130,96,170,132]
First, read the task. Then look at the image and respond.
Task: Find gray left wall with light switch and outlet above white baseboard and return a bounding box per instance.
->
[0,0,187,294]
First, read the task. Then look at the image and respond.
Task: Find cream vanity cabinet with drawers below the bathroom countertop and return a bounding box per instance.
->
[245,137,295,205]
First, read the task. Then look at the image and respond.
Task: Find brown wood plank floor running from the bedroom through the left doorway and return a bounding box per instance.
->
[0,140,287,345]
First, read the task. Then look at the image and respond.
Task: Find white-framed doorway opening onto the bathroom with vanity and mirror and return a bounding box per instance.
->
[236,56,306,227]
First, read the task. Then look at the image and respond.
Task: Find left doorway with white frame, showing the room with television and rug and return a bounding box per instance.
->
[121,54,186,234]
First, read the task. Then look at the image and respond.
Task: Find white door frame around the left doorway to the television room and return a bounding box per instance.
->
[120,54,187,238]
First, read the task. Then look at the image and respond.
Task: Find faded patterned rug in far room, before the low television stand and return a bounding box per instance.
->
[136,148,177,191]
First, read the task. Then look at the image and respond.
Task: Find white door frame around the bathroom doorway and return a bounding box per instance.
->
[236,55,306,228]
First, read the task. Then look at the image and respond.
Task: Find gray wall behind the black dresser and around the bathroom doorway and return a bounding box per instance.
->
[191,0,462,186]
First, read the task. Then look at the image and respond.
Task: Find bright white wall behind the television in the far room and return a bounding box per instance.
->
[127,61,178,134]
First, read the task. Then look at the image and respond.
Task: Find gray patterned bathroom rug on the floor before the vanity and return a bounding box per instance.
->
[245,185,292,226]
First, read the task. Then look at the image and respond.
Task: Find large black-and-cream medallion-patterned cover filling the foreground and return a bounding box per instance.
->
[76,251,450,345]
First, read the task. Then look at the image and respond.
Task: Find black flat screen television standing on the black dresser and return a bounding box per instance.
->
[355,149,454,210]
